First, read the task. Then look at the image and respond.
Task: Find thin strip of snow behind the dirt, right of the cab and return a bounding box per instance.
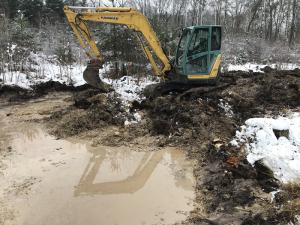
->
[227,63,299,72]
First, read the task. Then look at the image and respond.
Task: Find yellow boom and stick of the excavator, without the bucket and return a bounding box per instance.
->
[64,6,171,86]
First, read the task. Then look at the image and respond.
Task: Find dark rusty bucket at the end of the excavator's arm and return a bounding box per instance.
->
[83,59,111,92]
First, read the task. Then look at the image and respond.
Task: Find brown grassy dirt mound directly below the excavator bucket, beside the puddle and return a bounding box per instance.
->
[49,89,126,137]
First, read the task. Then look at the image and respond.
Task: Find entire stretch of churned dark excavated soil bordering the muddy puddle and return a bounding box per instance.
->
[0,68,300,225]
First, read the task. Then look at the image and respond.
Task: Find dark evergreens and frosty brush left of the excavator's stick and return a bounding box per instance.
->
[0,0,86,73]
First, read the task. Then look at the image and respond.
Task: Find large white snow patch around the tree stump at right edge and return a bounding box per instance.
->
[231,113,300,183]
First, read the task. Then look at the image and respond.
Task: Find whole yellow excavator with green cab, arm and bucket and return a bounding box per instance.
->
[64,6,222,89]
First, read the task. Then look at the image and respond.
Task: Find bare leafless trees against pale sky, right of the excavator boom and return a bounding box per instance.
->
[129,0,300,46]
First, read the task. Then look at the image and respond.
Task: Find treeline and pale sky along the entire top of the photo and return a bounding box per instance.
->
[0,0,300,45]
